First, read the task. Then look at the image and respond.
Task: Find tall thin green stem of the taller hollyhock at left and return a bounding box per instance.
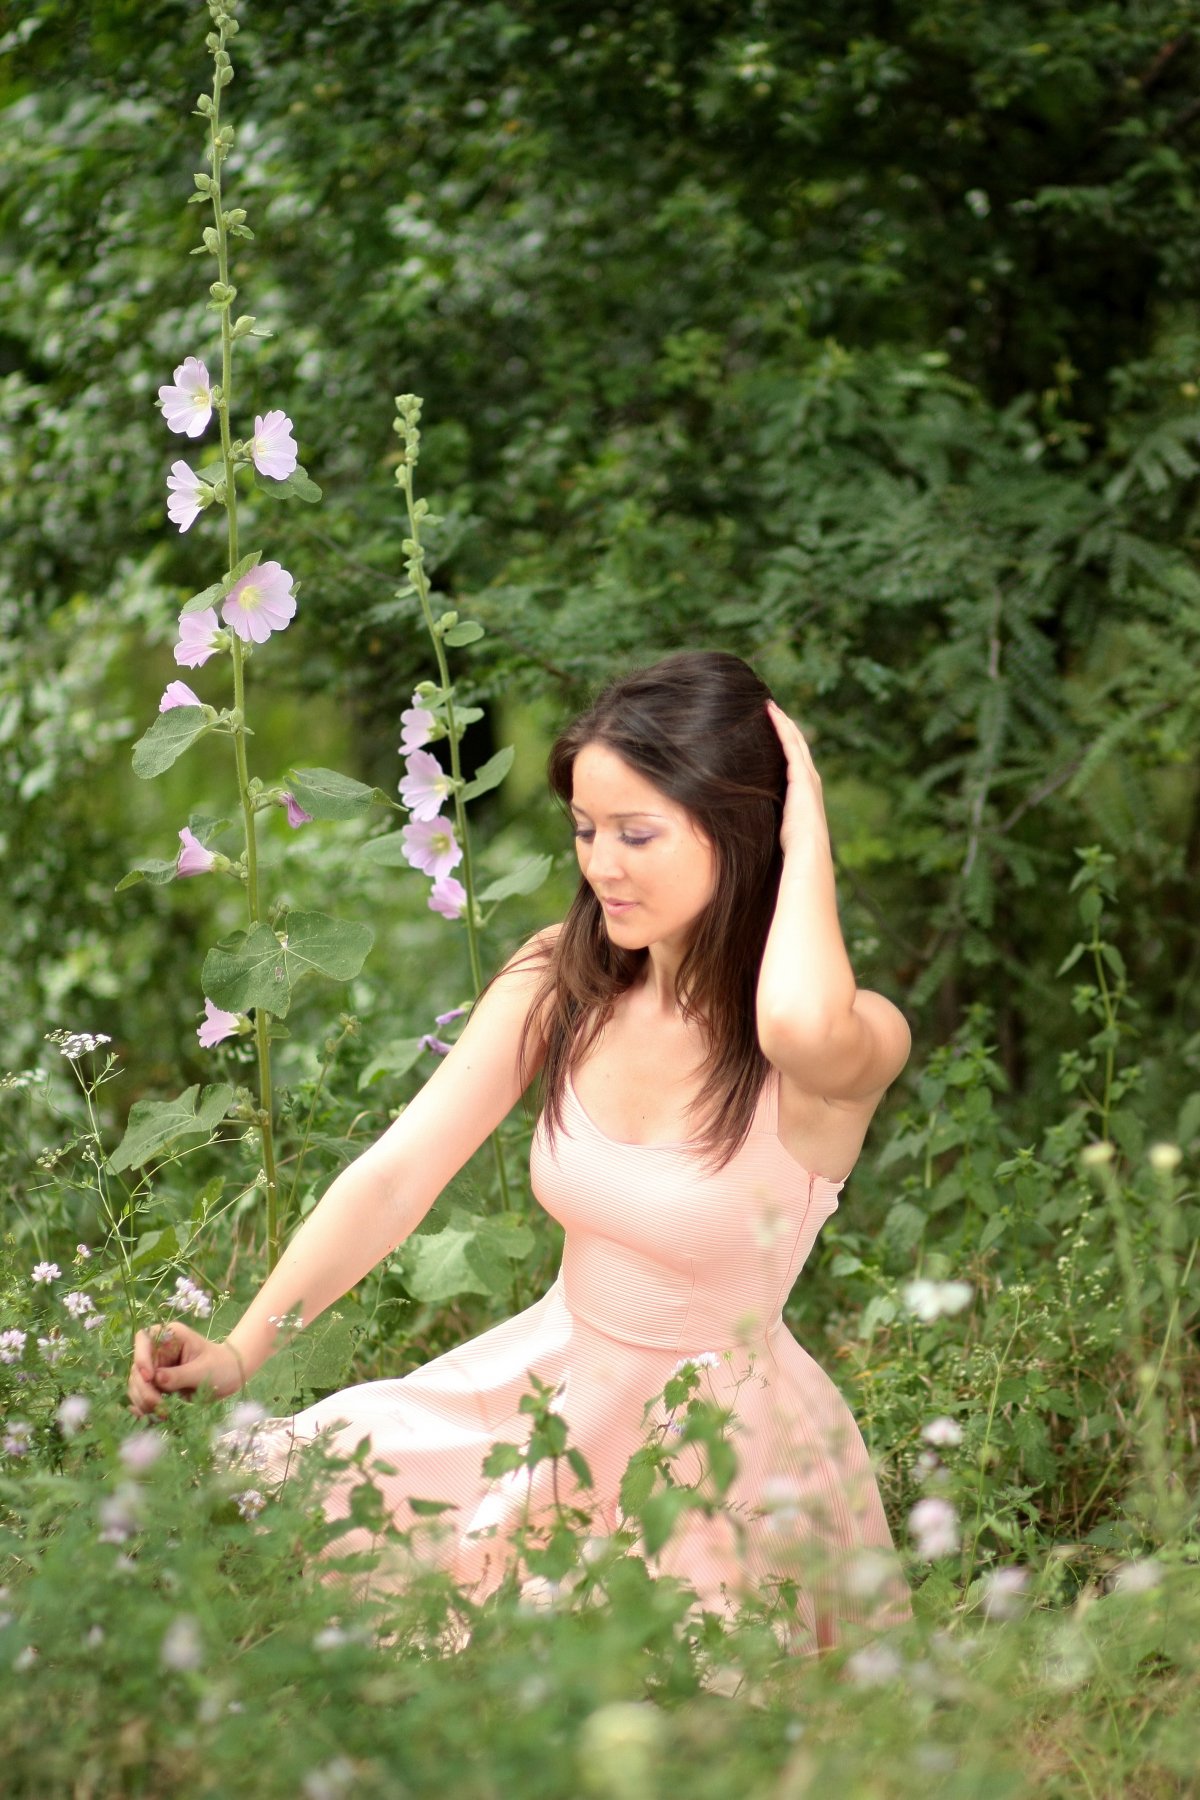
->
[209,25,281,1269]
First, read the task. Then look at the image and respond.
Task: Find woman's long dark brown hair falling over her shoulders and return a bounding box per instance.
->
[520,650,786,1168]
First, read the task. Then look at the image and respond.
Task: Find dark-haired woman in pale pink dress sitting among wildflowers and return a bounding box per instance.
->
[130,652,910,1645]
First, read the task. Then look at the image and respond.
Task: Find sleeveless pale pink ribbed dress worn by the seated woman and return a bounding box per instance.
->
[232,1078,910,1649]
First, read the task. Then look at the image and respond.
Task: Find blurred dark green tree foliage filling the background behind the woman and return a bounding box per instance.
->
[0,0,1200,1137]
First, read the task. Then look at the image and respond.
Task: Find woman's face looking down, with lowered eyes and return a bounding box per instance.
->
[570,743,716,954]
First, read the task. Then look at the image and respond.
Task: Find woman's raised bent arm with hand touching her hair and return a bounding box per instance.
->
[757,700,910,1100]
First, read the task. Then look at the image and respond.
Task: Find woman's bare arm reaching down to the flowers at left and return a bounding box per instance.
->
[130,940,557,1411]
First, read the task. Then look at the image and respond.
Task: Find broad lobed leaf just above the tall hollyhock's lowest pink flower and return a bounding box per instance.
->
[201,913,374,1019]
